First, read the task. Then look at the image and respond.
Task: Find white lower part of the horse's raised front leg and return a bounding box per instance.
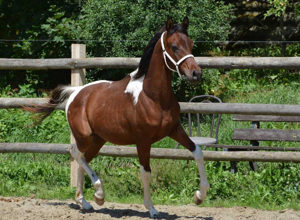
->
[193,145,209,201]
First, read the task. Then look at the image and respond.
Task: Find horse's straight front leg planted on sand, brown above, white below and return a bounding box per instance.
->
[136,142,159,218]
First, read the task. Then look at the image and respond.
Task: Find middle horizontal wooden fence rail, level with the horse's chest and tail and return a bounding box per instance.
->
[0,98,300,116]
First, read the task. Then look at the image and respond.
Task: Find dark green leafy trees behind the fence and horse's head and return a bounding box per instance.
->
[0,0,232,100]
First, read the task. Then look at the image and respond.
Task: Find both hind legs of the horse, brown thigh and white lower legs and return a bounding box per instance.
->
[71,135,106,210]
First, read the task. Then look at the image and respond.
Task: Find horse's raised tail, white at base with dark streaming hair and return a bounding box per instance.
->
[23,86,78,125]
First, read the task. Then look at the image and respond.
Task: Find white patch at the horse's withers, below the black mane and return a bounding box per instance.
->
[125,69,145,105]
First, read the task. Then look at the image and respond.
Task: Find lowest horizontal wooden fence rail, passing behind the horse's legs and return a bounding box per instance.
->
[0,143,300,163]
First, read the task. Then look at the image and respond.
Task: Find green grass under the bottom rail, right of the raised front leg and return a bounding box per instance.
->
[207,163,300,207]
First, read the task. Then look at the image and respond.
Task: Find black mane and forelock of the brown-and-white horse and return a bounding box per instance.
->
[134,24,188,79]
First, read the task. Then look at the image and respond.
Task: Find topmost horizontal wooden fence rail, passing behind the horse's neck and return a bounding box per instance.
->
[0,57,300,70]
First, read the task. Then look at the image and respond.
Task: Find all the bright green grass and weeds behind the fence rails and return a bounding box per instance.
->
[0,85,300,210]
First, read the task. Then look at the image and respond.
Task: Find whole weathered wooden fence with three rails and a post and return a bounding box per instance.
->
[0,44,300,186]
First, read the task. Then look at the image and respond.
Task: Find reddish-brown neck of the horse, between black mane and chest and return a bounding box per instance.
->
[143,47,174,107]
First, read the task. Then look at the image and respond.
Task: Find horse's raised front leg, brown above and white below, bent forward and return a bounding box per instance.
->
[169,122,209,205]
